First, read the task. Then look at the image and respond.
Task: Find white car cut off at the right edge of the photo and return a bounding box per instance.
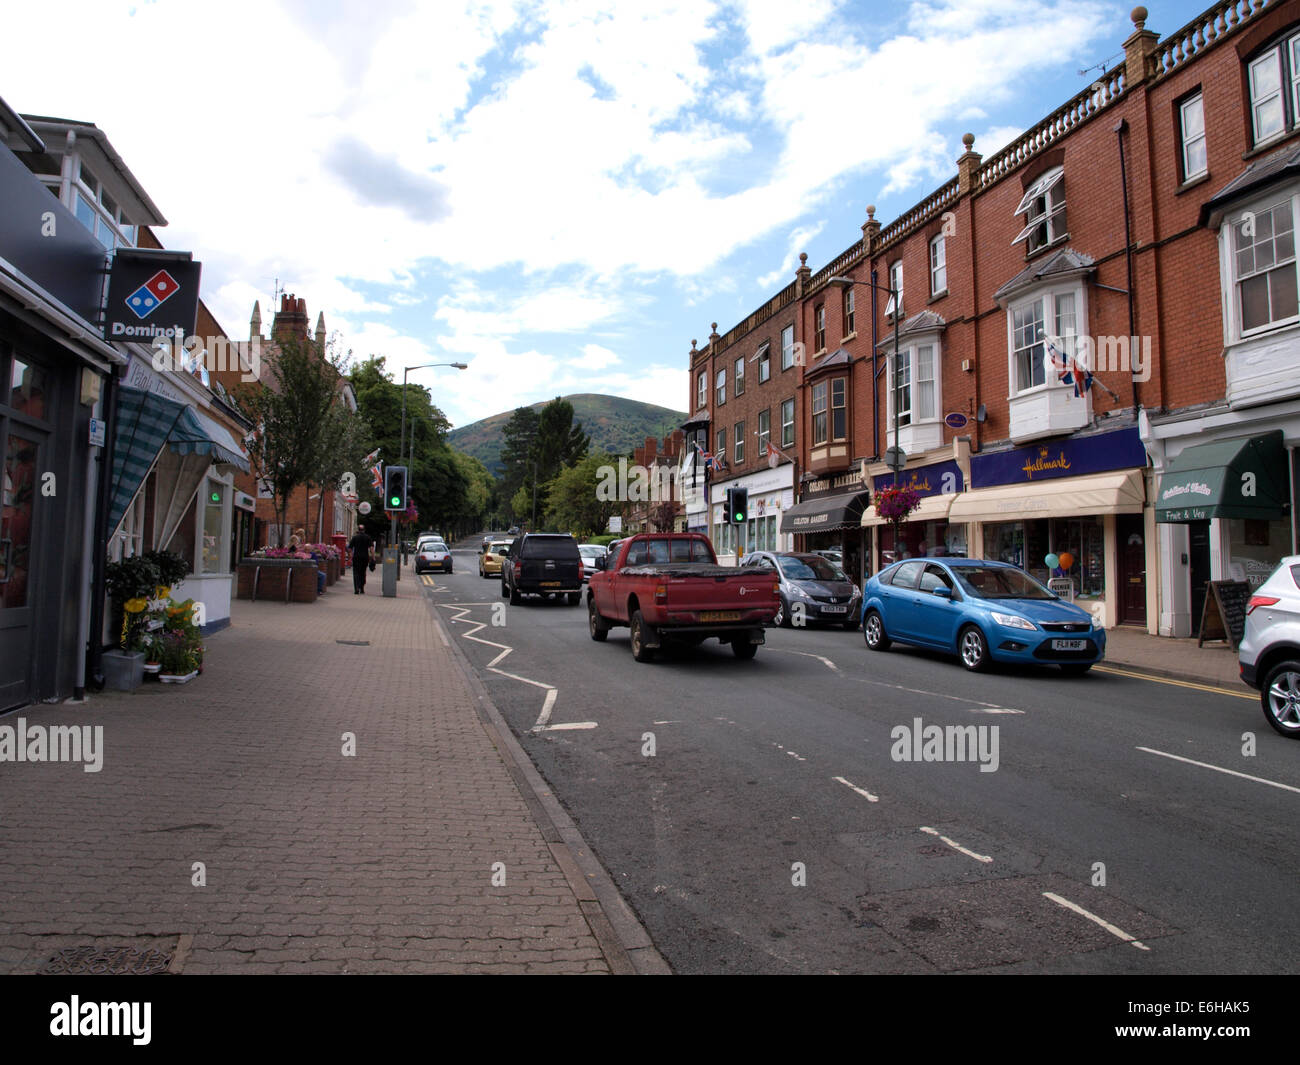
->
[1236,555,1300,740]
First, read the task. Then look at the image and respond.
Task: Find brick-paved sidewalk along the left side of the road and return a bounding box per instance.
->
[0,580,628,973]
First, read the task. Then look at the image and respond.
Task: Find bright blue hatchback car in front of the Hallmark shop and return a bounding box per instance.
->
[862,558,1106,676]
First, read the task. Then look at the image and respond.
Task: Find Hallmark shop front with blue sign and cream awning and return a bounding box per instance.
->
[948,427,1154,628]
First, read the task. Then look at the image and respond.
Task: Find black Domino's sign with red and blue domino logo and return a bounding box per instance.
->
[104,248,203,342]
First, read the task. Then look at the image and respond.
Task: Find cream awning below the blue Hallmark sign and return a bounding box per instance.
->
[948,469,1145,521]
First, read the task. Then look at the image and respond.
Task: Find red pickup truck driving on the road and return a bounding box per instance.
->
[586,533,781,662]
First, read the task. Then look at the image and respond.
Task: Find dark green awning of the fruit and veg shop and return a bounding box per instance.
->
[1156,429,1290,523]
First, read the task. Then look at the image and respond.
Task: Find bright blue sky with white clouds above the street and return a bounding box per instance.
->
[0,0,1209,425]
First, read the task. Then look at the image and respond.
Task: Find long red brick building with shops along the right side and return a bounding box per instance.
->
[685,0,1300,636]
